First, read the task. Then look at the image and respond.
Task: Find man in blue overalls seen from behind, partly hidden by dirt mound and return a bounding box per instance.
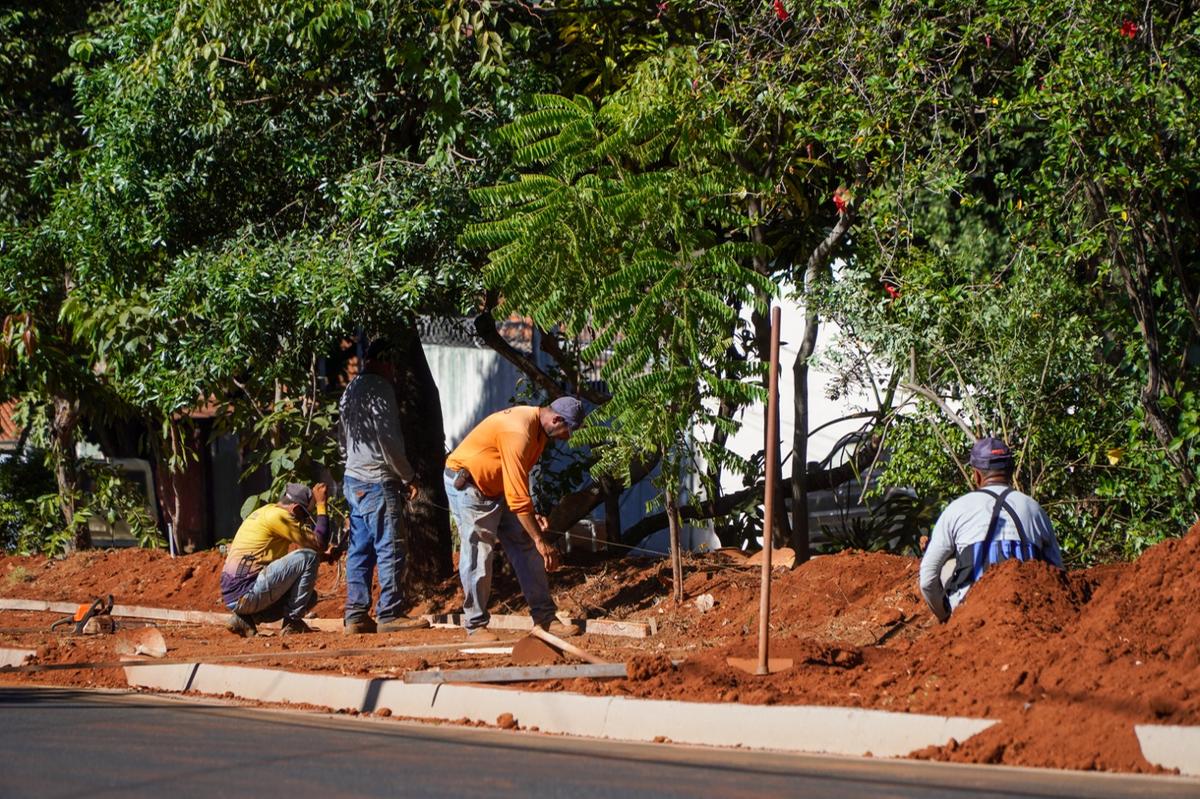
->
[920,438,1062,621]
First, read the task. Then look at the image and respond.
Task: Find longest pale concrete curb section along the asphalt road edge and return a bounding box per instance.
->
[117,663,996,757]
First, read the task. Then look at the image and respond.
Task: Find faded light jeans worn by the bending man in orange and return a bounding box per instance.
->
[445,467,558,630]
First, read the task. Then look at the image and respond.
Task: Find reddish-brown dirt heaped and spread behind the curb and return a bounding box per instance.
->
[0,525,1200,771]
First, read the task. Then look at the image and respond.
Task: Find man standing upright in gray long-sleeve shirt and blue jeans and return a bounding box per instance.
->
[338,340,428,633]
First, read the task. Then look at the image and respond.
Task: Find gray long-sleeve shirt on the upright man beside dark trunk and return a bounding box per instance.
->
[338,372,415,482]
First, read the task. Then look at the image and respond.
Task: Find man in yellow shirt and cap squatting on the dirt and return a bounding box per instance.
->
[221,482,329,637]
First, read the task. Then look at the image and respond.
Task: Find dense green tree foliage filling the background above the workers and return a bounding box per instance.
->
[0,0,1200,561]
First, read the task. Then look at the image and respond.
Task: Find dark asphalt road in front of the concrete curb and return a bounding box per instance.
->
[0,686,1200,799]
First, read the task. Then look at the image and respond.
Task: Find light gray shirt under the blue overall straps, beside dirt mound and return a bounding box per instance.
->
[920,486,1062,621]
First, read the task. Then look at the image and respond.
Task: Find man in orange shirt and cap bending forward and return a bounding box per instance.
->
[445,397,583,642]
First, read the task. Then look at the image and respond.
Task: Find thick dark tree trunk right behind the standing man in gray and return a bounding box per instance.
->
[396,331,454,585]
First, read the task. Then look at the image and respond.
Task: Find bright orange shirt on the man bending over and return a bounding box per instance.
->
[446,405,546,513]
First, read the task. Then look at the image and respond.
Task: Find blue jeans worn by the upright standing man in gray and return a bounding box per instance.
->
[342,476,408,621]
